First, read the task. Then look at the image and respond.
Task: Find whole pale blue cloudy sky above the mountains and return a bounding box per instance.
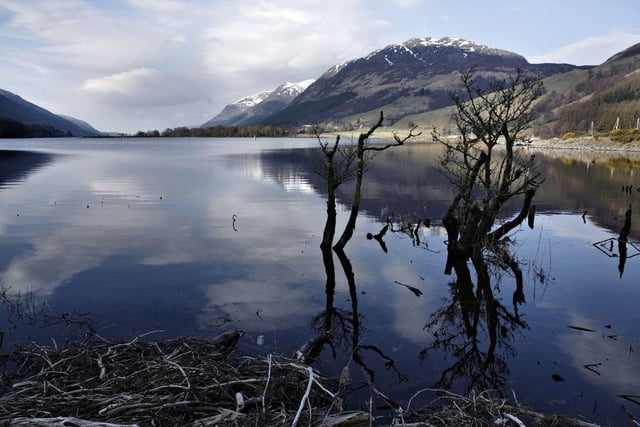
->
[0,0,640,132]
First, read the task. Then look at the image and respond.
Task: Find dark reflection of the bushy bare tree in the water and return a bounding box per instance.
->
[420,252,528,393]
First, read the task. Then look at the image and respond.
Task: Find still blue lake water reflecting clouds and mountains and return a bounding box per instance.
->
[0,139,640,425]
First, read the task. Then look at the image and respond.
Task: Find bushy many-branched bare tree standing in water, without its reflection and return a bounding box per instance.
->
[433,70,543,274]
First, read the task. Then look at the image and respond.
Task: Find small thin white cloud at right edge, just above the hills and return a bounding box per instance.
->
[528,32,640,65]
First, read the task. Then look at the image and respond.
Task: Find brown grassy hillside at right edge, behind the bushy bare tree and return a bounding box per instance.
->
[535,43,640,137]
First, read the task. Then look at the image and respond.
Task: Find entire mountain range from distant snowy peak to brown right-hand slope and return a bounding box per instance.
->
[203,38,640,139]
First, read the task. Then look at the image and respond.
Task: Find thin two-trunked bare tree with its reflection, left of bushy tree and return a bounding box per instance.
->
[296,112,420,407]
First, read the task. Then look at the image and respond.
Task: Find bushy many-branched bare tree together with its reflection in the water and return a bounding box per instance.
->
[420,70,542,392]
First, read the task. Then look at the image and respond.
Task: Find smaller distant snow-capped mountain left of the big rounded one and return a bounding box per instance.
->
[201,80,313,127]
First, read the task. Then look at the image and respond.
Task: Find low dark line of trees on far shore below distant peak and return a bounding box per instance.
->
[132,125,304,138]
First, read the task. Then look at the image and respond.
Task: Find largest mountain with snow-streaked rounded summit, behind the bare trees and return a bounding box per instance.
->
[263,37,579,126]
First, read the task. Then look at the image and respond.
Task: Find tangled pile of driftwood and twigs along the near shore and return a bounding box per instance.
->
[0,331,608,427]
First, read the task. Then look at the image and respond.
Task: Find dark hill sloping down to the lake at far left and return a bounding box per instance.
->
[0,89,100,136]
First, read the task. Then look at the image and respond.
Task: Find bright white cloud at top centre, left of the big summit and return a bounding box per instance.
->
[203,0,386,90]
